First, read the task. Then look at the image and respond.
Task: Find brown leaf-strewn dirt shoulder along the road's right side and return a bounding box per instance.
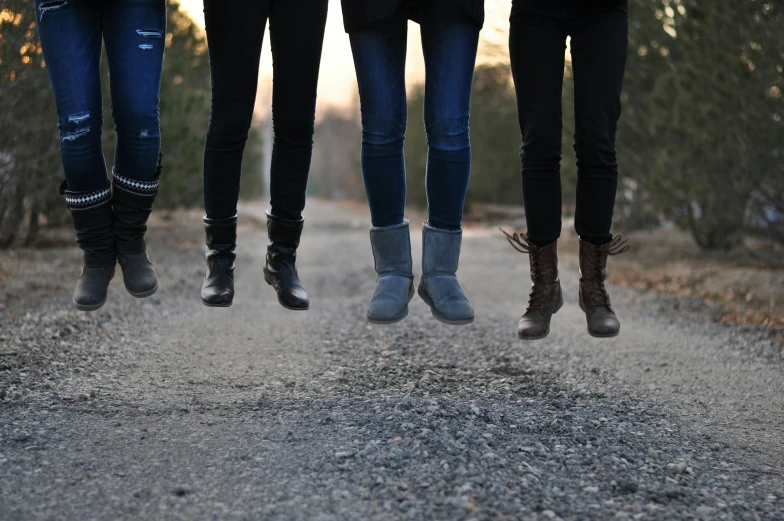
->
[467,205,784,349]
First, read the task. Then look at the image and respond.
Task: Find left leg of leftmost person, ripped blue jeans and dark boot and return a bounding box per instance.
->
[35,0,117,311]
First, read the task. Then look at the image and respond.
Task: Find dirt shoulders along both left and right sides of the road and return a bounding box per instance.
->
[0,201,784,345]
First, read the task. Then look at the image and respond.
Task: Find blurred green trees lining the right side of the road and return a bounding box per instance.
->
[406,0,784,249]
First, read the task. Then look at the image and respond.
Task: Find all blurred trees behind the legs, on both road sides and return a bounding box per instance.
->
[0,0,784,249]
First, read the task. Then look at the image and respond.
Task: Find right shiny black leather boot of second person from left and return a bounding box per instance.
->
[264,212,310,311]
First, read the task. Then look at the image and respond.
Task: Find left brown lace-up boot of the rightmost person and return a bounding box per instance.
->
[501,230,563,340]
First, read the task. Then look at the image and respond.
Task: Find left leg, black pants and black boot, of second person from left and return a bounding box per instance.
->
[201,0,270,307]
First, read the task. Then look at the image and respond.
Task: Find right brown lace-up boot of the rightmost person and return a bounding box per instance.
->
[579,235,629,338]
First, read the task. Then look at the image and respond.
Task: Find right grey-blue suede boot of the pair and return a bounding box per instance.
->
[418,223,474,326]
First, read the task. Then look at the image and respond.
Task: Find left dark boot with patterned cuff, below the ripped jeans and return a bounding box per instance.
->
[60,181,117,311]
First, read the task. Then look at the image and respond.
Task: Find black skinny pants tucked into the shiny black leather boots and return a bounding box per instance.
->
[204,0,327,219]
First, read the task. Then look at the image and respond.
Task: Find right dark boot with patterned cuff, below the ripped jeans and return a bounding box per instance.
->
[112,157,161,298]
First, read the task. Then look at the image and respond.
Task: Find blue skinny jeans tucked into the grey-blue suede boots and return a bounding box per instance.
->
[349,2,479,230]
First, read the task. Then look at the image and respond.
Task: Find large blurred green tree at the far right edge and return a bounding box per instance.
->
[618,0,784,249]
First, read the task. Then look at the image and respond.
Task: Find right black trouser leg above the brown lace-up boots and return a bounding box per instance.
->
[571,3,628,246]
